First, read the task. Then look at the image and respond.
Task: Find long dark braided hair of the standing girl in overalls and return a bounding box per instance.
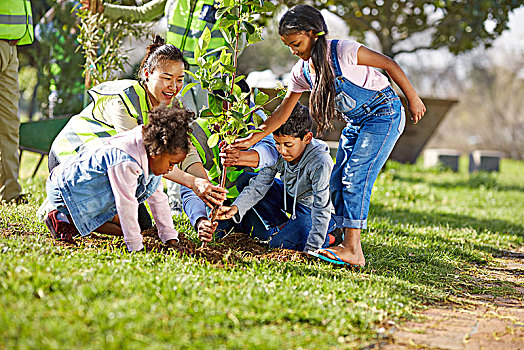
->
[278,5,338,133]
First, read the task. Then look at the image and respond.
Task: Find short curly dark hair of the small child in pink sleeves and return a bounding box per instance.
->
[142,104,195,155]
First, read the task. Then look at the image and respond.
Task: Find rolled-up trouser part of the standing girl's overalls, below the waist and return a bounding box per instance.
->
[329,93,406,229]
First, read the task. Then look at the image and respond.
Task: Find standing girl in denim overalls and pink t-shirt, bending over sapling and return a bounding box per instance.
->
[235,5,426,266]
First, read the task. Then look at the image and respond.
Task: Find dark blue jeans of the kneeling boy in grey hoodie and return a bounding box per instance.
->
[236,173,335,251]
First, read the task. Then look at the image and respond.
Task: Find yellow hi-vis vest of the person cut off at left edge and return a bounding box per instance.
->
[0,0,34,45]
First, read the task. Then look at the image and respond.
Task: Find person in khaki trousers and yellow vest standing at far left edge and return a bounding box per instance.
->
[0,0,34,204]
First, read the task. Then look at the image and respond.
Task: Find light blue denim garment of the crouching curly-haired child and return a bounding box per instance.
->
[46,146,162,236]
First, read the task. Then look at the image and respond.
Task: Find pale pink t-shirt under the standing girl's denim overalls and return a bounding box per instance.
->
[288,40,390,93]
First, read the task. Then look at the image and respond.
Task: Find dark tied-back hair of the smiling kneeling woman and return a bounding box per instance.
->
[138,35,189,82]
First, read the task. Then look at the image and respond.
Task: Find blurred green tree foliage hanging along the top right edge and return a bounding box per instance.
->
[279,0,523,57]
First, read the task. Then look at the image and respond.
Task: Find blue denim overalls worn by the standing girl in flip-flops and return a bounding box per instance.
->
[303,40,406,229]
